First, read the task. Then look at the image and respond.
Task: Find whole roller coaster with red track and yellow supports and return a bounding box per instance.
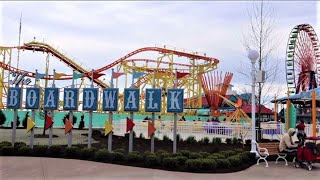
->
[0,41,219,114]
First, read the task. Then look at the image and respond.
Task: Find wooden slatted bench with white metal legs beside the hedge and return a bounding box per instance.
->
[256,142,288,167]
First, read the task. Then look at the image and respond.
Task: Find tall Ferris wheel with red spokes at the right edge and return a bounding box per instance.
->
[286,24,320,95]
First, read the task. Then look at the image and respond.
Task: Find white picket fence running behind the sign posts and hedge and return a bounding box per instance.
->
[108,121,320,140]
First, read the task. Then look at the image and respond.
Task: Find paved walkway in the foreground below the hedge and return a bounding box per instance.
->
[0,157,320,180]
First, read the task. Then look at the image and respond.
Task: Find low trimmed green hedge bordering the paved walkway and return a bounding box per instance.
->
[0,141,255,172]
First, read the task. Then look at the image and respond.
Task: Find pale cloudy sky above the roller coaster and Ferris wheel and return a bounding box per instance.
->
[0,1,319,105]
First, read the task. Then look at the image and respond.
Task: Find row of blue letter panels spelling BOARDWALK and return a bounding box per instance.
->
[7,87,184,113]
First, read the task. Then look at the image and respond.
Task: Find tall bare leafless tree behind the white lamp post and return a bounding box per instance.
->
[238,1,281,140]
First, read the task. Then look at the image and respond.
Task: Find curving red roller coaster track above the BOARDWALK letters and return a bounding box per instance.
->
[0,41,219,88]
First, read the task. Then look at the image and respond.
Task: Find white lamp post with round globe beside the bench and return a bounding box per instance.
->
[248,49,259,154]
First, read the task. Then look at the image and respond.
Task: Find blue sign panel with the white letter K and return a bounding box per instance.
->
[167,89,183,113]
